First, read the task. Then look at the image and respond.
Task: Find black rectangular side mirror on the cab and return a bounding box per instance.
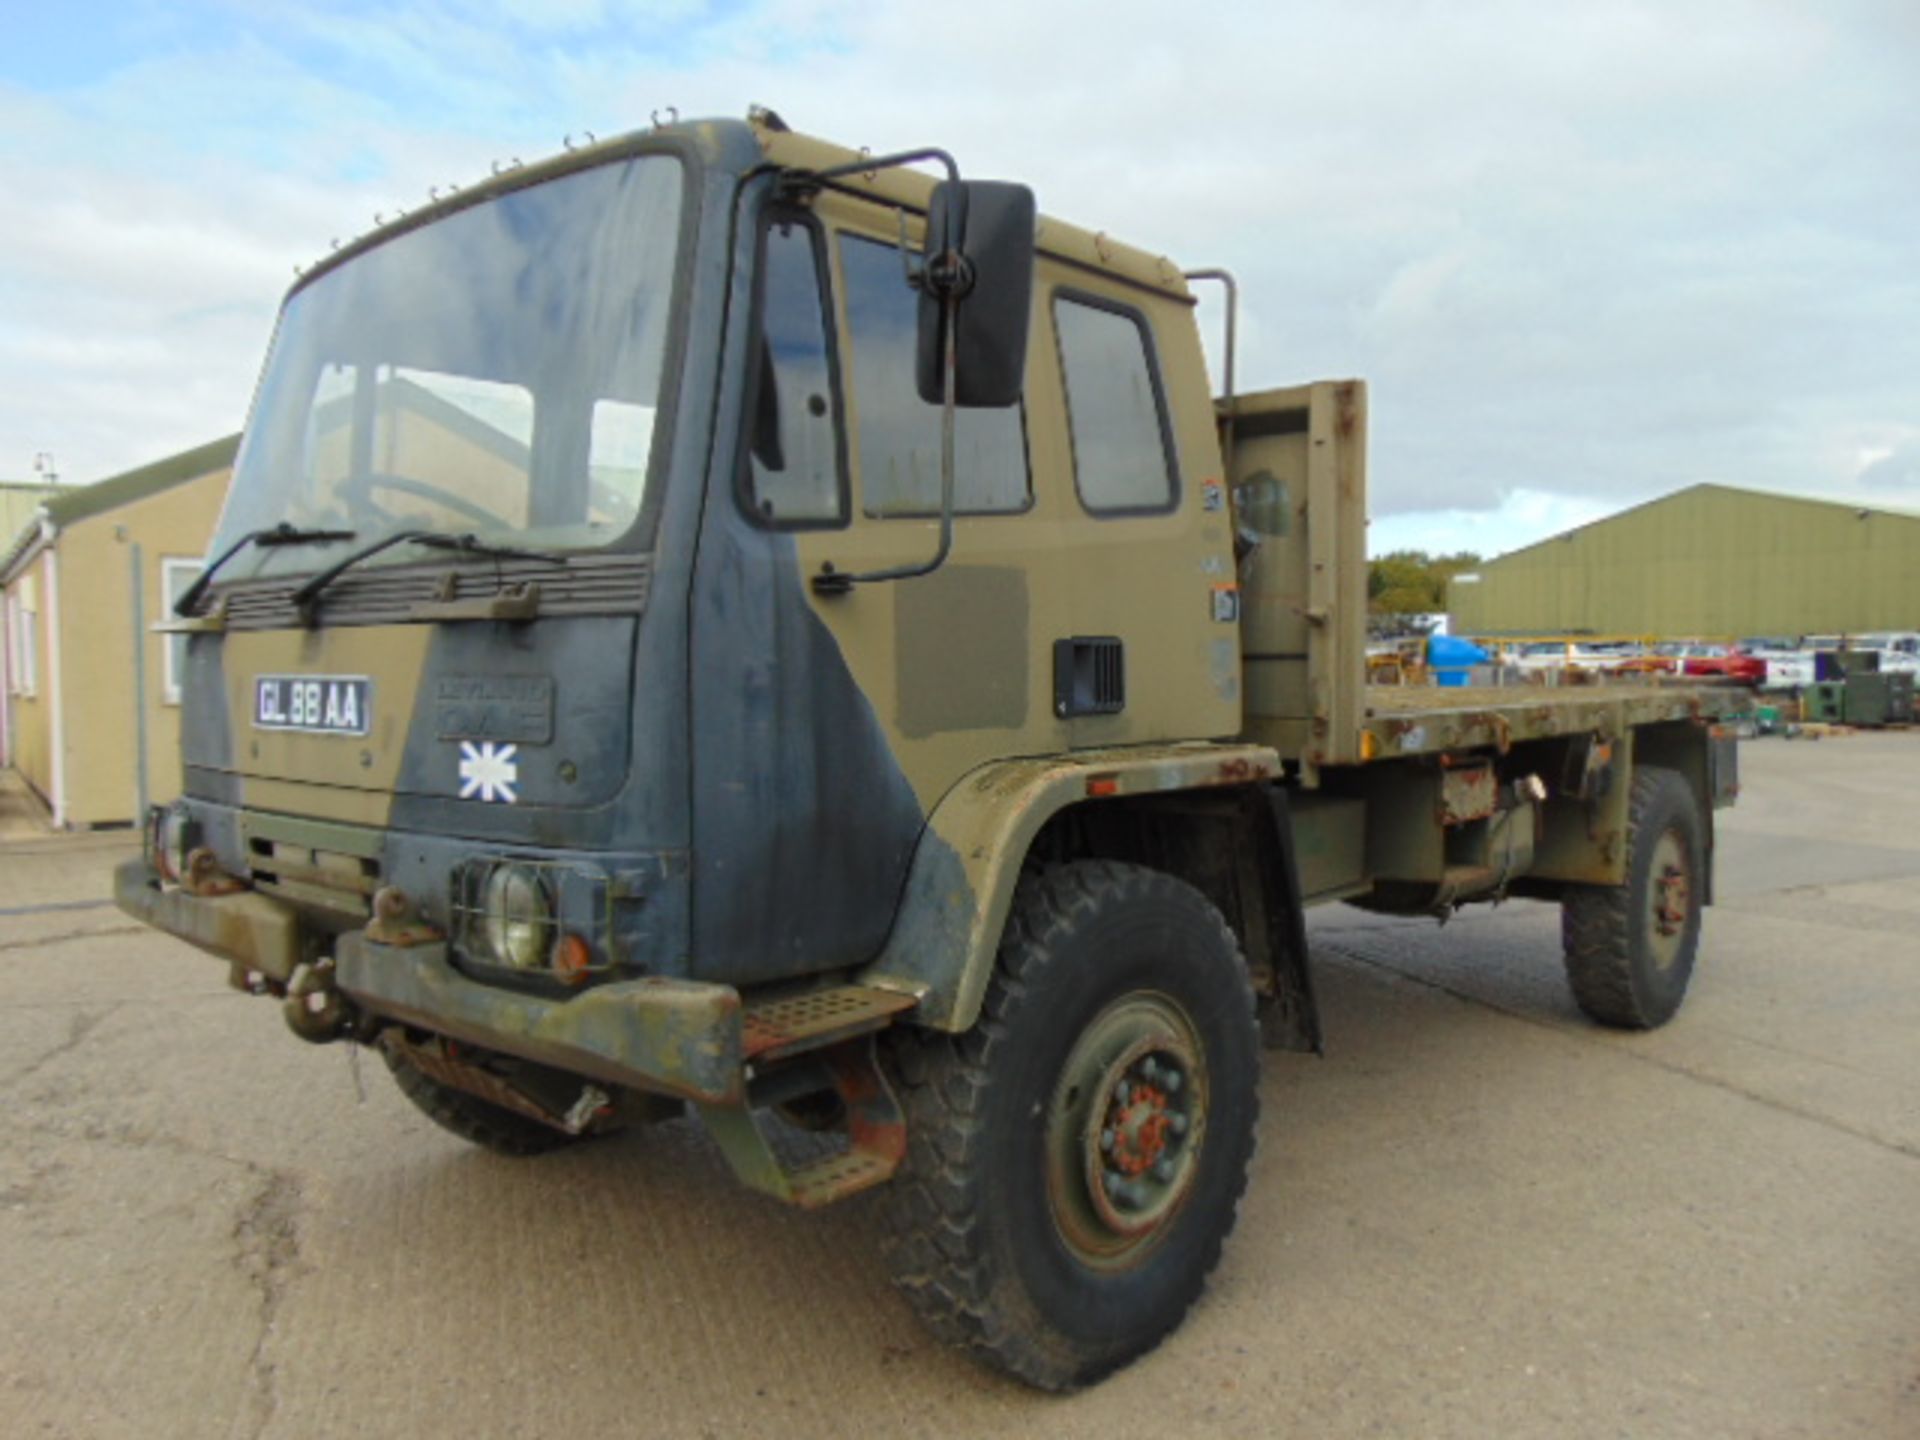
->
[916,180,1035,409]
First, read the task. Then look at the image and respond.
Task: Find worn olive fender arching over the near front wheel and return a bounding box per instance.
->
[860,741,1281,1033]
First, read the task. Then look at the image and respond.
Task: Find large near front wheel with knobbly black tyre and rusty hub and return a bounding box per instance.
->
[883,860,1260,1390]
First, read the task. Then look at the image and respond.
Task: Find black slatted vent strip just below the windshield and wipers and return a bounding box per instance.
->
[200,555,653,630]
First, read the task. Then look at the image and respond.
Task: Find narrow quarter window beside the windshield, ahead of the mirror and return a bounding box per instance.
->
[743,217,847,526]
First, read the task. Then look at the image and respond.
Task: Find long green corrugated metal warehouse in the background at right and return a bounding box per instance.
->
[1448,486,1920,637]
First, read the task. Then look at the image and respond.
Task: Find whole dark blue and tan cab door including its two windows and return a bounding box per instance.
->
[689,196,1069,985]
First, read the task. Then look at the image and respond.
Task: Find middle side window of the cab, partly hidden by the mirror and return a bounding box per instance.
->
[839,234,1033,518]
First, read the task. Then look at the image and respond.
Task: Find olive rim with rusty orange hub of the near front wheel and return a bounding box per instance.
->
[1046,991,1208,1269]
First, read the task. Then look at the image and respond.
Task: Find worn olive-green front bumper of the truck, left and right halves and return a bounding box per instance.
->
[113,860,747,1104]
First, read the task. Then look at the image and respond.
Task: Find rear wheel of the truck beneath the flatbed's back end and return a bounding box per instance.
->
[1561,766,1705,1029]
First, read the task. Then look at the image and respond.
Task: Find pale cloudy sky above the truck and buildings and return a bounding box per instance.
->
[0,0,1920,555]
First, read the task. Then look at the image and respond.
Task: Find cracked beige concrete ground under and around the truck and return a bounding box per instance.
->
[0,733,1920,1440]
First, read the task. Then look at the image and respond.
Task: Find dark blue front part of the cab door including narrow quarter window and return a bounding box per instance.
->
[689,207,924,985]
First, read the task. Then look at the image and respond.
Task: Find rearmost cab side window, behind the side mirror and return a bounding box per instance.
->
[1054,296,1173,515]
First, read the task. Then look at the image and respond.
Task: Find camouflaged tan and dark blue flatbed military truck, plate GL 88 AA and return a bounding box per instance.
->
[117,111,1736,1388]
